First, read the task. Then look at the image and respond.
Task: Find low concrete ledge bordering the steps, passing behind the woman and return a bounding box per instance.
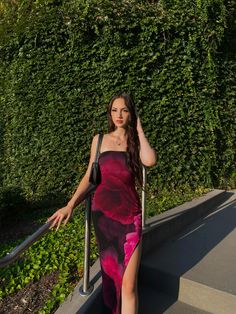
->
[55,190,229,314]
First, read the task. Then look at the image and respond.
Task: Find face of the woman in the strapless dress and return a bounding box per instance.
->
[111,98,130,128]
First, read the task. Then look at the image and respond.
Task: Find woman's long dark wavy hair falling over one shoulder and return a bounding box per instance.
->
[107,92,143,187]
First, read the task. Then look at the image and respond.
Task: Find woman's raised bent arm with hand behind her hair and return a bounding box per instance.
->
[137,117,157,167]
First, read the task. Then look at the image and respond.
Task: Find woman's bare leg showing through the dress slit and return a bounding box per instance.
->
[121,241,142,314]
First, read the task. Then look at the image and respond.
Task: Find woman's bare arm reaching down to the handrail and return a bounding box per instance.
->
[47,135,98,230]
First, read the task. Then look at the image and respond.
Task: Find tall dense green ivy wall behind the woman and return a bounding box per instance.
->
[0,0,236,199]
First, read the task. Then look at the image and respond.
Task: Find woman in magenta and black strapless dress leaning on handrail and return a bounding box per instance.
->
[48,93,156,314]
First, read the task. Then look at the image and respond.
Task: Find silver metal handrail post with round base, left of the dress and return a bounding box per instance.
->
[79,195,93,296]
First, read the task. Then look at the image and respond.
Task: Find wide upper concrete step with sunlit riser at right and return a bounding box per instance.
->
[139,194,236,314]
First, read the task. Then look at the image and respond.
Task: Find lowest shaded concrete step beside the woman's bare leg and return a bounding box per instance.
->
[139,286,209,314]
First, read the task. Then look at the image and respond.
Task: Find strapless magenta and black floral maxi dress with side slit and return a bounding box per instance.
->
[92,151,142,314]
